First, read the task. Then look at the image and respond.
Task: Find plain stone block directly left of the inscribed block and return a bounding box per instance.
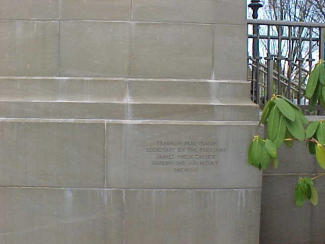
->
[0,121,105,187]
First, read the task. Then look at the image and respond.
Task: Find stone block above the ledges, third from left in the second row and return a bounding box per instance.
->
[130,23,213,79]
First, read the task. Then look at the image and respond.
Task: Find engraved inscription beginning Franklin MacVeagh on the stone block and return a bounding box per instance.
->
[145,141,226,173]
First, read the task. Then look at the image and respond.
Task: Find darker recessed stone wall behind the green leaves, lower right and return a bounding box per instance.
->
[260,117,325,244]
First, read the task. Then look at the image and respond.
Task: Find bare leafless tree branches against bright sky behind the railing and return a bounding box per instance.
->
[251,0,325,104]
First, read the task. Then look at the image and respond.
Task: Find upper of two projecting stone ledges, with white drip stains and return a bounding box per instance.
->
[0,77,252,105]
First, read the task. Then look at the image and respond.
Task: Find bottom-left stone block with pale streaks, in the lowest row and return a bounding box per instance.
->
[0,187,123,244]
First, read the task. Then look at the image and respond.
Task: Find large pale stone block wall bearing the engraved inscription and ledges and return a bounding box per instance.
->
[0,0,261,244]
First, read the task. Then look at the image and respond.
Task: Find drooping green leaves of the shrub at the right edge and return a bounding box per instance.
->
[247,60,325,207]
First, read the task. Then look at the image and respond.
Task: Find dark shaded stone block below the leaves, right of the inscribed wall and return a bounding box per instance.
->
[260,175,314,244]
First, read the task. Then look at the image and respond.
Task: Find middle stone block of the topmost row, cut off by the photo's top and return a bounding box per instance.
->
[61,0,131,20]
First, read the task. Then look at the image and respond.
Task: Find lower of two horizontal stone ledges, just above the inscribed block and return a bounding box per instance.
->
[0,101,258,121]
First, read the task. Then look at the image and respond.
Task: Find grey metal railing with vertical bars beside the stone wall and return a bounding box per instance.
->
[248,20,325,112]
